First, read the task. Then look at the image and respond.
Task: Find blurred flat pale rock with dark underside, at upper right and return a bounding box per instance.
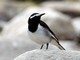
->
[41,2,80,17]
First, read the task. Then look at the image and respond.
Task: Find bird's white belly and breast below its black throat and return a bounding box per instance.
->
[28,25,51,44]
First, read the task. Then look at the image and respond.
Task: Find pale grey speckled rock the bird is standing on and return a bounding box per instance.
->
[14,50,80,60]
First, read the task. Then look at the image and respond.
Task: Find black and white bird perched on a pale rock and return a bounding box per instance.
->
[28,13,65,50]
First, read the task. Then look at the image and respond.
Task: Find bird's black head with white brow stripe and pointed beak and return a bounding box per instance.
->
[28,13,45,24]
